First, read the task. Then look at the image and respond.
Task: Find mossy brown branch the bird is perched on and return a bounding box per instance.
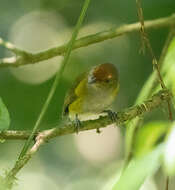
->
[0,90,171,141]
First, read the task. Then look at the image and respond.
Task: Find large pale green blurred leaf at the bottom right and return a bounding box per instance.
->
[112,145,163,190]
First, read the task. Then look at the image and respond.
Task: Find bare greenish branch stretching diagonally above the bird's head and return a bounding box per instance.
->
[0,14,175,67]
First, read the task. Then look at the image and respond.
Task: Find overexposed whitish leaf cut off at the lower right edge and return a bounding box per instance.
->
[163,122,175,176]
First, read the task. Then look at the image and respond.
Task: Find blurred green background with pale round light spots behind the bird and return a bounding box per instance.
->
[0,0,175,190]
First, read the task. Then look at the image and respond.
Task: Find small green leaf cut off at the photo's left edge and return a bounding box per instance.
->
[0,98,10,131]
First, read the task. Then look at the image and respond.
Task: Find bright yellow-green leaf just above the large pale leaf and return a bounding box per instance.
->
[133,121,170,156]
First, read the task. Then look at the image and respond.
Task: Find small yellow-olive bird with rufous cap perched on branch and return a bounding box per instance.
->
[63,63,119,125]
